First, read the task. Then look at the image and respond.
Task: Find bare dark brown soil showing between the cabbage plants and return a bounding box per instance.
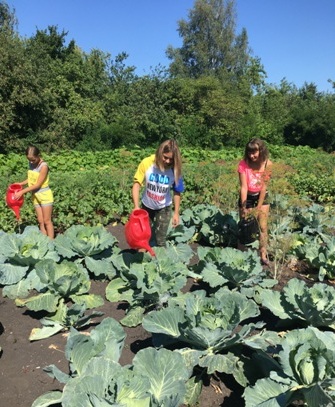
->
[0,224,304,407]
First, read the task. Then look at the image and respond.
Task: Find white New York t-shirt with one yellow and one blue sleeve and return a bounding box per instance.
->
[134,154,184,210]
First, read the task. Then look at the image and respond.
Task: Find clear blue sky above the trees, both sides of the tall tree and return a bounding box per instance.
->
[7,0,335,92]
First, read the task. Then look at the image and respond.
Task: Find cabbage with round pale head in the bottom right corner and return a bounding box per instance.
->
[243,327,335,407]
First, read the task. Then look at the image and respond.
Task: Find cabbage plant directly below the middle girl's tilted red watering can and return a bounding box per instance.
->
[106,244,193,326]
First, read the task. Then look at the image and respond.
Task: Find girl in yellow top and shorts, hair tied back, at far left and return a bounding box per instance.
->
[15,146,54,239]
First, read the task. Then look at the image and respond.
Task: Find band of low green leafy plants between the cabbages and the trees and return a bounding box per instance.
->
[0,146,335,232]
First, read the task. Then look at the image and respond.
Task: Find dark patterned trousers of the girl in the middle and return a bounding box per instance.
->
[142,204,171,246]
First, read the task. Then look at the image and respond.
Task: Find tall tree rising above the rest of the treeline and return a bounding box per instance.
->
[166,0,249,78]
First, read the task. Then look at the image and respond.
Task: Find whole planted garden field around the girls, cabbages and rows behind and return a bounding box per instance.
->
[0,146,335,407]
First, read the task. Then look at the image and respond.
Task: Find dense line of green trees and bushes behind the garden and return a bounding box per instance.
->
[0,0,335,153]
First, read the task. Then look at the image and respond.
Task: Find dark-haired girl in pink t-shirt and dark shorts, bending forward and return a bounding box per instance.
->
[238,138,272,265]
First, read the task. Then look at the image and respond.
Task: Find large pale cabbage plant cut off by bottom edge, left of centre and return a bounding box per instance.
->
[32,318,190,407]
